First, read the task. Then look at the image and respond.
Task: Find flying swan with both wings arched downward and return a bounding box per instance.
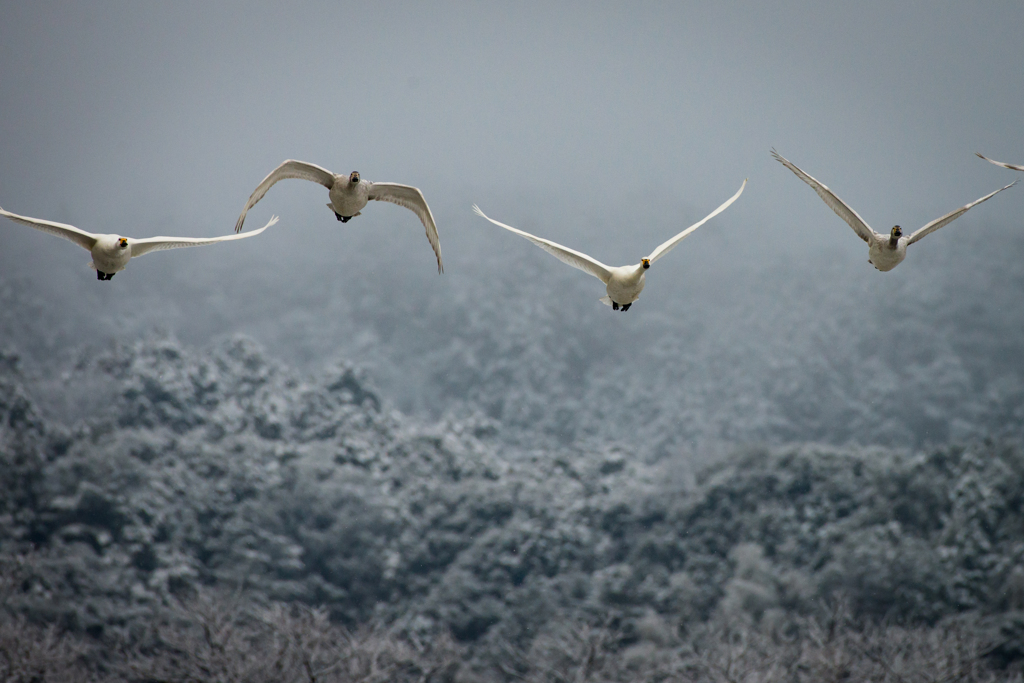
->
[234,159,444,272]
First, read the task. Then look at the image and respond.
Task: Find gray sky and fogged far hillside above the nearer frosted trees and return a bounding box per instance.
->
[0,2,1024,455]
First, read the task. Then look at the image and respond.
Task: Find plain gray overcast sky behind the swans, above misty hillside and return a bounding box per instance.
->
[0,1,1024,348]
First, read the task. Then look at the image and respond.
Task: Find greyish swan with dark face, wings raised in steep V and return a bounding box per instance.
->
[771,150,1017,272]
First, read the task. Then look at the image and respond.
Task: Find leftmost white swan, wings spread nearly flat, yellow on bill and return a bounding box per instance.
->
[0,209,278,280]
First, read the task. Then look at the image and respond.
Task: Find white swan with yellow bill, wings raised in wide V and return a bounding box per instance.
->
[473,180,746,311]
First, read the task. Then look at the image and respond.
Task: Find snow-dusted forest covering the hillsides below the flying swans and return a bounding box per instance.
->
[0,245,1024,680]
